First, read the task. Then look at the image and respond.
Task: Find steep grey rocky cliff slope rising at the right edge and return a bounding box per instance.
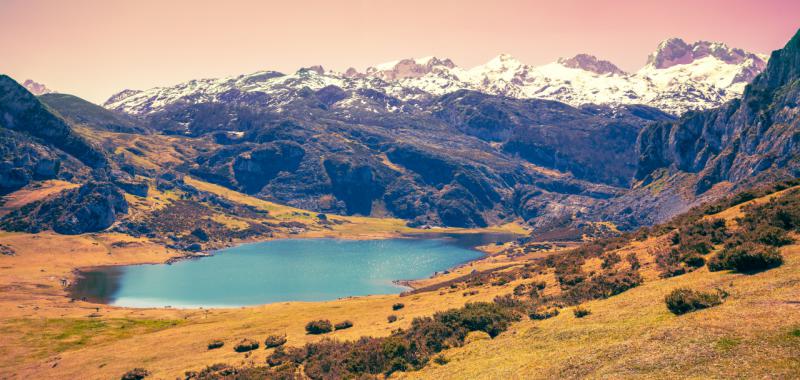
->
[607,32,800,229]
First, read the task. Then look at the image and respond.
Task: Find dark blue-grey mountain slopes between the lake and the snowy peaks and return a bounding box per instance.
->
[106,81,670,227]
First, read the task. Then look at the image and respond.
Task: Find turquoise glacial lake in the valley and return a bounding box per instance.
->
[71,234,518,308]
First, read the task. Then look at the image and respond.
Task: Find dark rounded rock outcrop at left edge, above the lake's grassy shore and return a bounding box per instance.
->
[0,182,128,235]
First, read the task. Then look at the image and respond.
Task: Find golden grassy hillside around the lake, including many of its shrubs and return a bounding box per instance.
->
[0,173,800,379]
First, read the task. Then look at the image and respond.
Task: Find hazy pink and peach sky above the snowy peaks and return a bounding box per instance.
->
[0,0,800,103]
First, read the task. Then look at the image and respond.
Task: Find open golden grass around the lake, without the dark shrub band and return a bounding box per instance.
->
[0,179,800,379]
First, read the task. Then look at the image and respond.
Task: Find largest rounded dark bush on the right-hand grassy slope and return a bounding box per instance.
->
[708,243,783,273]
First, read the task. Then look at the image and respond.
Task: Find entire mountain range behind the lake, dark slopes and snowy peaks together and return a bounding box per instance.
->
[0,31,800,233]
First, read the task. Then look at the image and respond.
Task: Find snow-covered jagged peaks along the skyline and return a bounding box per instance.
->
[105,39,765,115]
